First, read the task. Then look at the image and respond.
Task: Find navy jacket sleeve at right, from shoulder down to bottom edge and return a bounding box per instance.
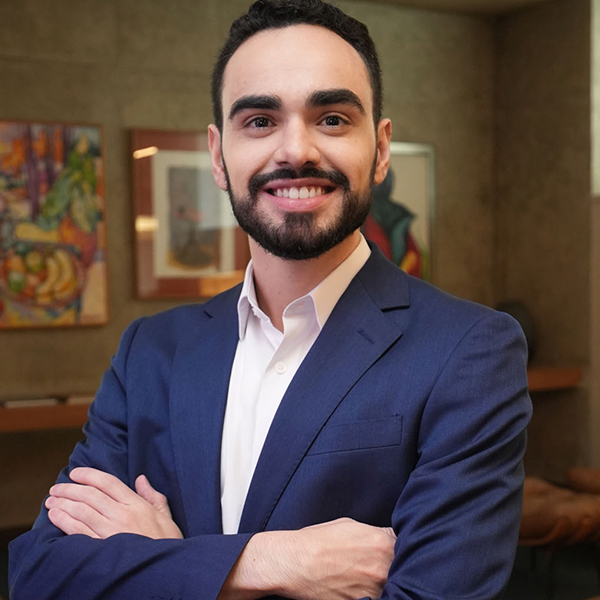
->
[381,313,531,600]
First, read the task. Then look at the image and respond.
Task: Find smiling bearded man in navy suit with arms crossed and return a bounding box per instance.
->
[10,0,530,600]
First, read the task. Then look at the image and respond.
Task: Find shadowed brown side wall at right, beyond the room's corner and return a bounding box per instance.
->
[495,0,592,480]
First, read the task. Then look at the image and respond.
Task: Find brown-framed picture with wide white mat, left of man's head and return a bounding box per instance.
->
[132,129,250,299]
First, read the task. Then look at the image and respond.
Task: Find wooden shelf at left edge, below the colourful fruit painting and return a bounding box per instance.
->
[0,404,89,433]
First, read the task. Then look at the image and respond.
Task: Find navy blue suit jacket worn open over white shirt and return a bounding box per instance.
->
[10,245,530,600]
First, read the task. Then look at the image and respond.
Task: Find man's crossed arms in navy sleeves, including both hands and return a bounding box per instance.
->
[10,310,529,600]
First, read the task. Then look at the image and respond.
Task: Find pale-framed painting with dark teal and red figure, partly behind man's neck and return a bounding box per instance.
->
[362,142,435,280]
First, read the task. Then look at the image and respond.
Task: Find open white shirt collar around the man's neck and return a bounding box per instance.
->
[238,234,371,340]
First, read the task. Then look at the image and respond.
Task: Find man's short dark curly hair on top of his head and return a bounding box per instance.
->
[212,0,383,130]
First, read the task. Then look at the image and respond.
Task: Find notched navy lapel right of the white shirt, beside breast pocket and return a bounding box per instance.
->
[239,250,408,533]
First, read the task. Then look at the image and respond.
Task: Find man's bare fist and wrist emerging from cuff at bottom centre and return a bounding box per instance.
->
[219,518,396,600]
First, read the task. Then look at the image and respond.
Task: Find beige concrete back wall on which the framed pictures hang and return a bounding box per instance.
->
[0,0,494,527]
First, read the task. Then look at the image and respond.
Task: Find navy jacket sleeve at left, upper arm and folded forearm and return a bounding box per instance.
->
[9,321,251,600]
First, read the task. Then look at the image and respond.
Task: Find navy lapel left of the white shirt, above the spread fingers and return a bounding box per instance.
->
[169,288,239,535]
